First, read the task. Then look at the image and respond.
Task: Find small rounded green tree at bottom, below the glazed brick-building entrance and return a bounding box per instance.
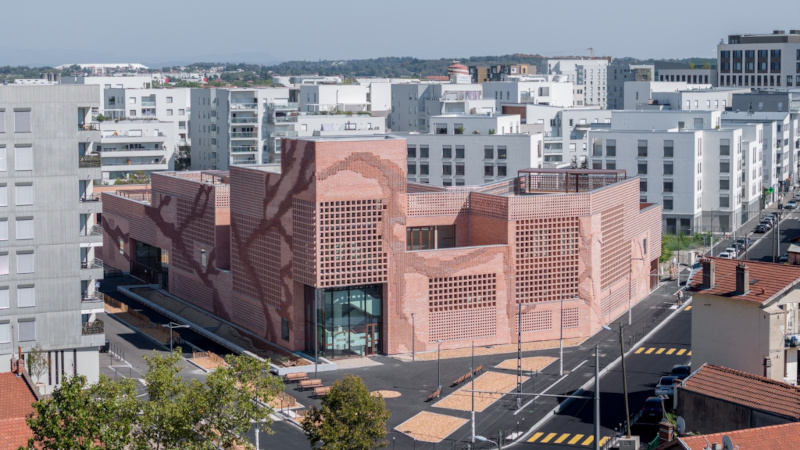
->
[303,375,390,450]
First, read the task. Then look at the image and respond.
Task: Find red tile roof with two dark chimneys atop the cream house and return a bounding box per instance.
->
[689,258,800,303]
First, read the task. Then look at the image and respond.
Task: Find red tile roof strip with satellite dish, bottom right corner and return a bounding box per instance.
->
[678,423,800,450]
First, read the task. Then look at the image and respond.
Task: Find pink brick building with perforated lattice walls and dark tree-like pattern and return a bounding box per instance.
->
[103,136,661,357]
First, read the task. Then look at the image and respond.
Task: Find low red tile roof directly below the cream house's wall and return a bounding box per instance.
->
[678,364,800,420]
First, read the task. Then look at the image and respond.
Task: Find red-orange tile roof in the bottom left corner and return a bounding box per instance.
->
[0,373,36,450]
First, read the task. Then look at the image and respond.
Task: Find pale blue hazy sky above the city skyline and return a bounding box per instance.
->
[0,0,800,67]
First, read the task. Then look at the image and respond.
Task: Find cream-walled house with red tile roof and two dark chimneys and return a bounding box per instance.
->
[688,258,800,384]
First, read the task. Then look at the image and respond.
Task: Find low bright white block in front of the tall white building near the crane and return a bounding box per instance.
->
[483,75,574,111]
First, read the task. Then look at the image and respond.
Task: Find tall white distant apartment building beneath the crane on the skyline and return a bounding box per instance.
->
[547,58,609,108]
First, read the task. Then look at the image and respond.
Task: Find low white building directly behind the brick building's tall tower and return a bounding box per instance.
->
[266,109,386,163]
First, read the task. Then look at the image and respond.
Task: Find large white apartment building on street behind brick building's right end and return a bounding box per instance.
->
[589,111,763,234]
